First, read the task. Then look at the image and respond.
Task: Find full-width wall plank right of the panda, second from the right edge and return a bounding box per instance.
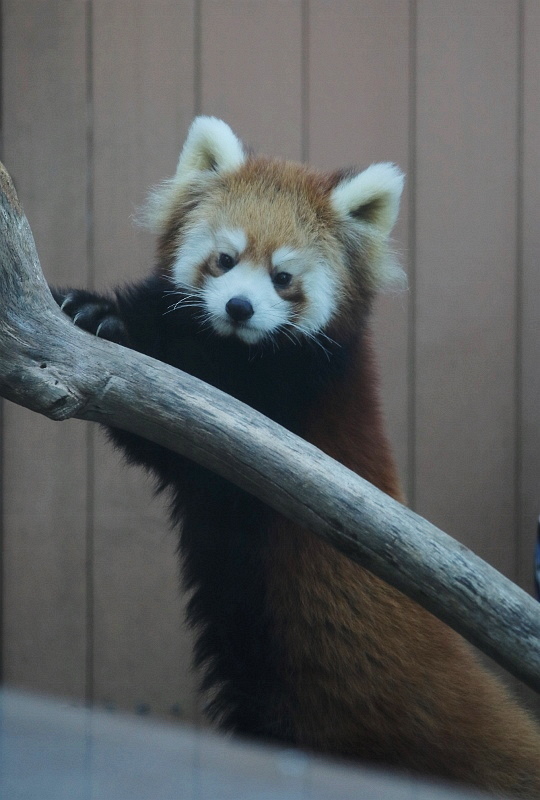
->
[415,0,519,577]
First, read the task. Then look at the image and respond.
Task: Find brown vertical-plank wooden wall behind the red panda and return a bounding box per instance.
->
[1,0,540,718]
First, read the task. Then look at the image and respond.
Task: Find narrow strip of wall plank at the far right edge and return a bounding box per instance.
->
[518,0,540,590]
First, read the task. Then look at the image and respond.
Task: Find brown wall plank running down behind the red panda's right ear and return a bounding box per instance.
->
[307,0,410,484]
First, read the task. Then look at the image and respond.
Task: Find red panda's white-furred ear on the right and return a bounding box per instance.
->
[330,163,404,237]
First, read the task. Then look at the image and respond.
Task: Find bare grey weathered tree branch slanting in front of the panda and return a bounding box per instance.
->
[0,162,540,691]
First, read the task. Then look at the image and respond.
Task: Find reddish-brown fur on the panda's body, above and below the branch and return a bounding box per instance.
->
[268,332,540,798]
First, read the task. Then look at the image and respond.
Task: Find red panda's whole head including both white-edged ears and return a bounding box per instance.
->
[141,117,403,344]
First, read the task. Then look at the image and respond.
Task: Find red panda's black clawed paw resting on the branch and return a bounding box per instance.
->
[51,289,129,346]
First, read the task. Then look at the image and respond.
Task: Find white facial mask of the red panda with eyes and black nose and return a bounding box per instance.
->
[172,225,339,344]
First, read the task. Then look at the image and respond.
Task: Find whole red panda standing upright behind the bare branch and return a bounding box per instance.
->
[54,117,540,798]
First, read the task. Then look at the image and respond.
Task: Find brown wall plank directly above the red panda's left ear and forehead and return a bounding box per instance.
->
[200,0,302,160]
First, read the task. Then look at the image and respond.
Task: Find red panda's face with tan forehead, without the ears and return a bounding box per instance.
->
[171,166,347,344]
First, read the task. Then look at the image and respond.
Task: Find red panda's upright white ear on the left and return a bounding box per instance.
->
[174,117,245,186]
